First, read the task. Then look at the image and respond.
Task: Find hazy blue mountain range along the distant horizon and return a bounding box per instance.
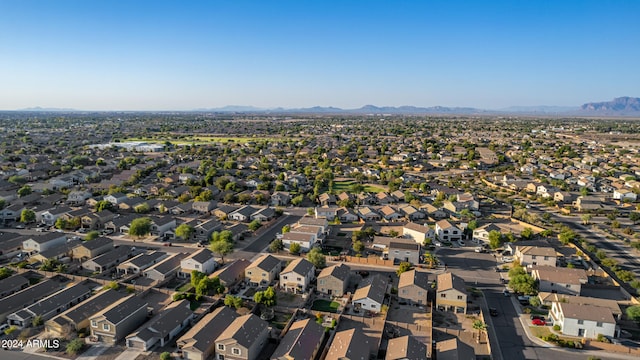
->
[13,96,640,117]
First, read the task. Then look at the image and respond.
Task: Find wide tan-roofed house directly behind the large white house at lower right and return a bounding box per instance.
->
[531,266,588,295]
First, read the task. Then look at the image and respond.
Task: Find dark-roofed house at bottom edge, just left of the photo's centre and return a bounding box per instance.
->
[271,319,325,360]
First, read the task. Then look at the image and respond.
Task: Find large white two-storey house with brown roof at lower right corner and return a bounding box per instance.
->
[549,301,617,339]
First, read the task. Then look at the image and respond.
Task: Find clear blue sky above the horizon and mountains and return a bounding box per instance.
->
[0,0,640,110]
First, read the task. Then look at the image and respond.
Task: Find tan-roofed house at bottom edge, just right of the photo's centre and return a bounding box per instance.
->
[324,328,376,360]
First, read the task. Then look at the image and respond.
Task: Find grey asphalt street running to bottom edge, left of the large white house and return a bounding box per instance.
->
[437,246,586,360]
